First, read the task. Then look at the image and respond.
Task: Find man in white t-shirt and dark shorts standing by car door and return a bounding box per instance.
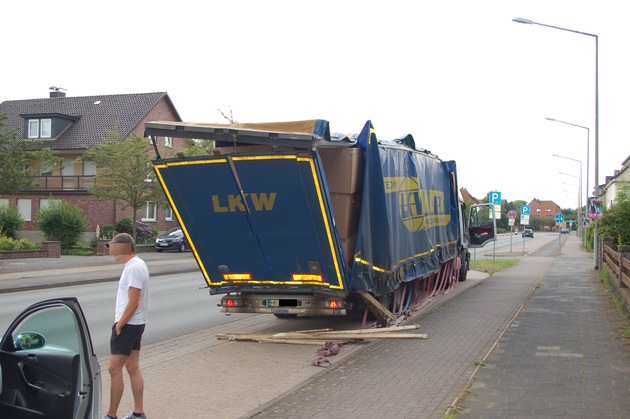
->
[103,233,149,419]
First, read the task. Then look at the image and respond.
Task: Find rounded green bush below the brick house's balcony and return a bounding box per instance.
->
[36,199,88,249]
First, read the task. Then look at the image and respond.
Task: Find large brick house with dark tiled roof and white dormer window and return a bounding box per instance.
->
[0,88,185,240]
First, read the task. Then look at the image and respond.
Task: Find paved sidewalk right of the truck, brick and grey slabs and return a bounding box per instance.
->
[252,235,630,419]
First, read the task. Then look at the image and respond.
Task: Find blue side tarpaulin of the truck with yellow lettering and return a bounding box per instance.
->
[350,121,458,295]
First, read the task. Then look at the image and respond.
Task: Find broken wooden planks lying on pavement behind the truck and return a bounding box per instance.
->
[216,325,427,345]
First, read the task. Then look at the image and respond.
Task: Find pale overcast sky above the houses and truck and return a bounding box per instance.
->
[0,0,630,208]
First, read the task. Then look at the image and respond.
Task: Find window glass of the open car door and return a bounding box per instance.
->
[13,306,81,353]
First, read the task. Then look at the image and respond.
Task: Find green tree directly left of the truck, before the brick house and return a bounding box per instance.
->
[82,124,166,239]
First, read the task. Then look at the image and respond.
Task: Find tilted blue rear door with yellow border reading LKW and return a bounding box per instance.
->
[154,151,347,294]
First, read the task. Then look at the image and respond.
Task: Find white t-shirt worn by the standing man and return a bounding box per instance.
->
[115,256,149,324]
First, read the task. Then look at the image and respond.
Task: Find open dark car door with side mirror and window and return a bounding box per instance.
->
[0,298,101,419]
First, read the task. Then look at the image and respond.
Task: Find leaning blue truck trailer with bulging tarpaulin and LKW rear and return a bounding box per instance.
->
[145,120,494,324]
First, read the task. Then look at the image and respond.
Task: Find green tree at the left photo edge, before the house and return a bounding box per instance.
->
[0,114,61,194]
